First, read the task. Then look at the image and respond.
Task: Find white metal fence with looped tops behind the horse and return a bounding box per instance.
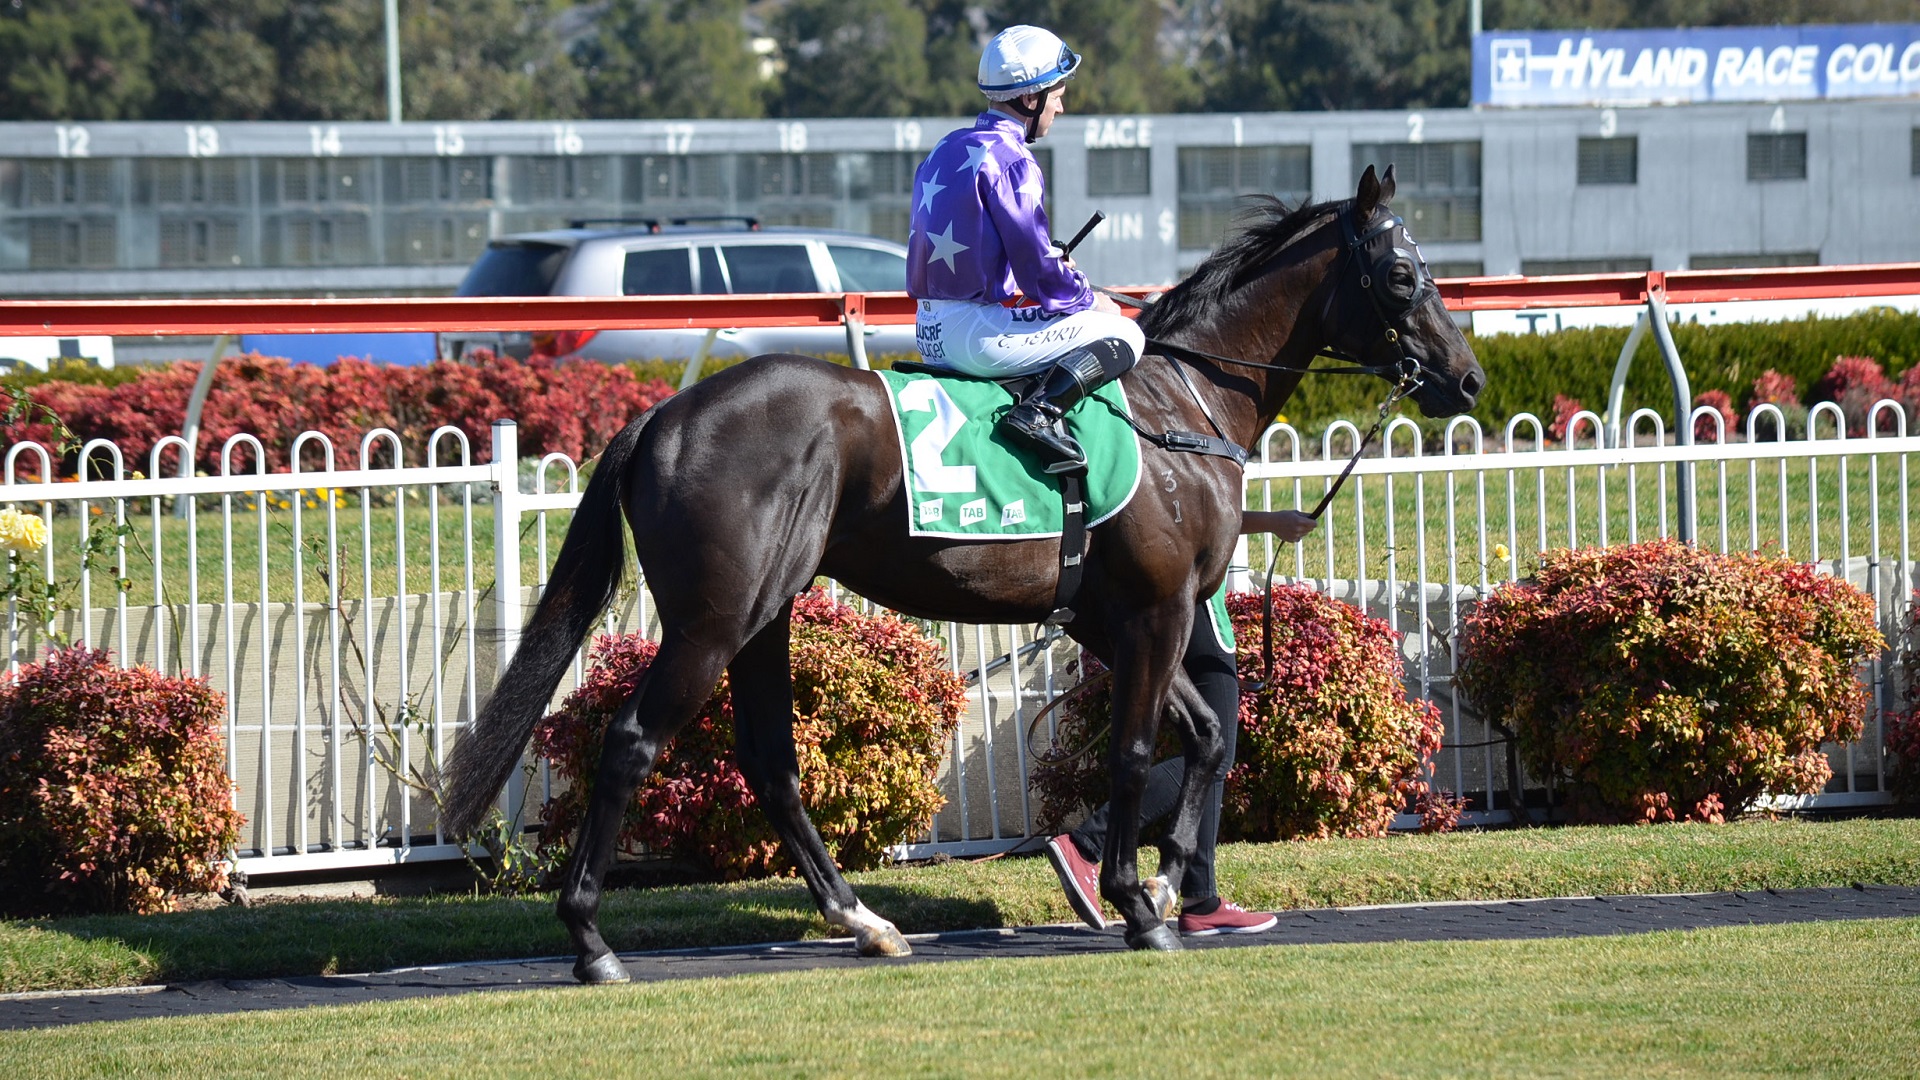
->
[0,402,1920,874]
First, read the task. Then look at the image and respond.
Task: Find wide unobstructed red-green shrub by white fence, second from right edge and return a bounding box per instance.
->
[1455,540,1882,822]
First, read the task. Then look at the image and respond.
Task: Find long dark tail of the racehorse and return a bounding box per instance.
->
[440,409,653,838]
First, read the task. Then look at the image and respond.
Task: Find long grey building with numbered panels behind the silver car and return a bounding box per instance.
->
[0,100,1920,298]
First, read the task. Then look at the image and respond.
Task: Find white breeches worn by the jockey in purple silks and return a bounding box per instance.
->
[918,300,1146,379]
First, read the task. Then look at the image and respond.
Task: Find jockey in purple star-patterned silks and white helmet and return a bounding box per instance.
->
[906,27,1146,473]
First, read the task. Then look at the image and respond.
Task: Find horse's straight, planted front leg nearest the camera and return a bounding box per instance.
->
[1100,603,1192,949]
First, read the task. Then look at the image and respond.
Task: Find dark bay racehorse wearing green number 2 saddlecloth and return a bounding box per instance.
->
[444,167,1484,982]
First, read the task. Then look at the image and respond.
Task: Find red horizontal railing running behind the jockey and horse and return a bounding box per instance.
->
[0,263,1920,336]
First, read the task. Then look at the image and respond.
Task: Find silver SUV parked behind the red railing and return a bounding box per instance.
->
[440,217,918,361]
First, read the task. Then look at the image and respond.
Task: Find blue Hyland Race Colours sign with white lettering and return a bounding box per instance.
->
[1473,23,1920,106]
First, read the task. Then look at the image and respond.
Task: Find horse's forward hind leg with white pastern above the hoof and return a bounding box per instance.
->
[728,601,912,957]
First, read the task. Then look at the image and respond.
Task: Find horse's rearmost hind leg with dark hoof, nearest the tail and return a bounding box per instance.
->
[559,636,730,982]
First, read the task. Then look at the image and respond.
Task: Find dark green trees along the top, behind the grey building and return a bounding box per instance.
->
[0,0,1912,121]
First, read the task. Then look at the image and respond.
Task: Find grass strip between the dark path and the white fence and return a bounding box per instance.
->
[11,819,1920,992]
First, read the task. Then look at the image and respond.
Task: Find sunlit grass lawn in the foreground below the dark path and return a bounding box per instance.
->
[0,919,1920,1078]
